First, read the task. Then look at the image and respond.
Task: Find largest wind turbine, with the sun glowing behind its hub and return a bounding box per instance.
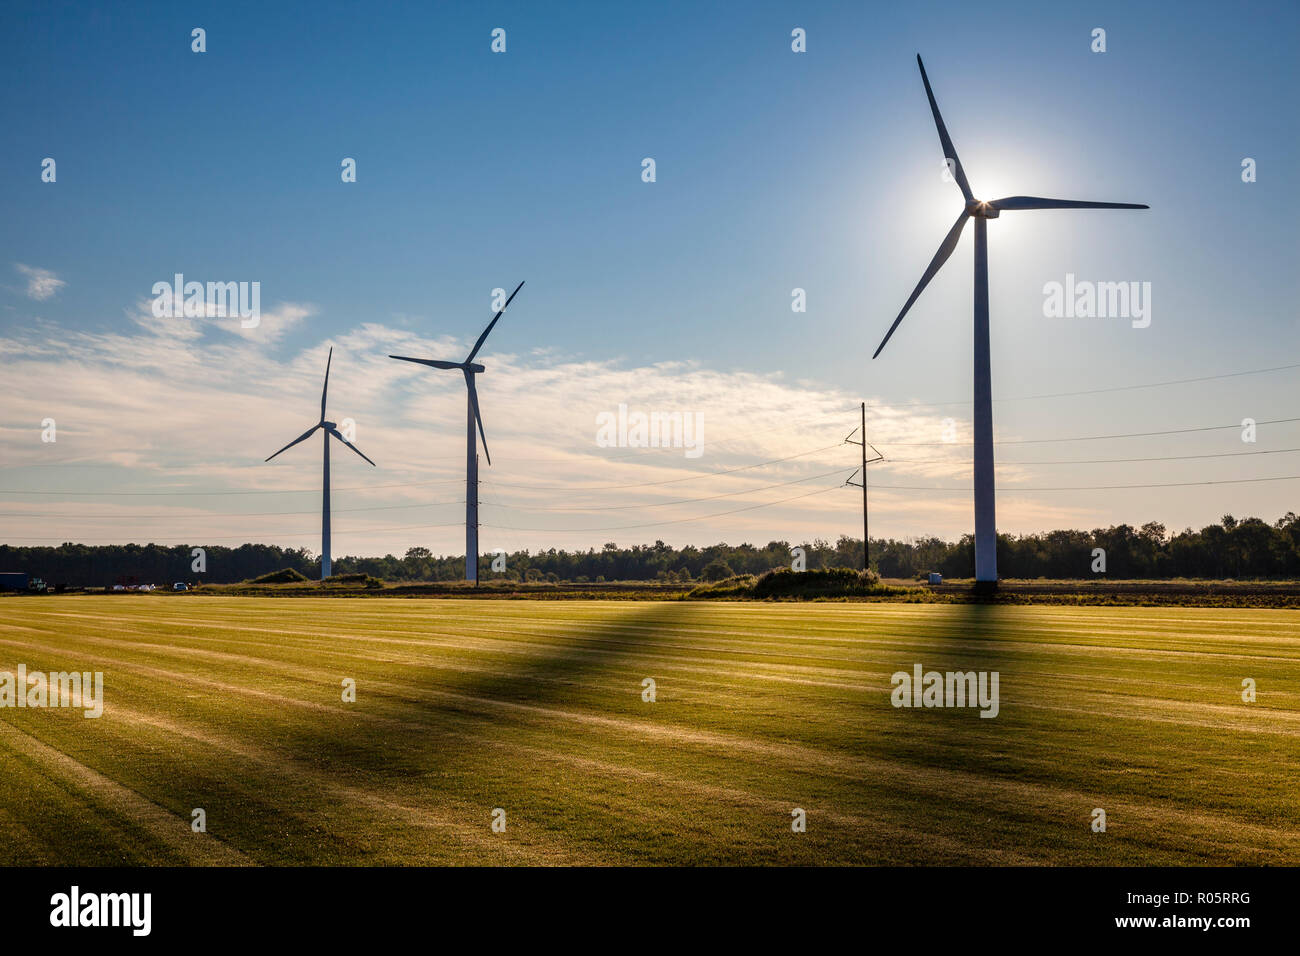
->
[871,55,1151,589]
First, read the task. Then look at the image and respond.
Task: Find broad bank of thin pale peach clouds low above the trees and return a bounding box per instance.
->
[0,310,1138,555]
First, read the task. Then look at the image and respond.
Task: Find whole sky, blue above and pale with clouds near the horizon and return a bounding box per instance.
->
[0,3,1300,553]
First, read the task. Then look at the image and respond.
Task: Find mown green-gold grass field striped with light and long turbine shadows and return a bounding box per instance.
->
[0,594,1300,865]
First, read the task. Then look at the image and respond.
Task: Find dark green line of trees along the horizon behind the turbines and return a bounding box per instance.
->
[0,511,1300,587]
